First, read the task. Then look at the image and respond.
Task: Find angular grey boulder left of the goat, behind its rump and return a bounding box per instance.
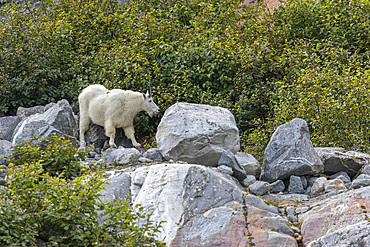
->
[12,100,77,144]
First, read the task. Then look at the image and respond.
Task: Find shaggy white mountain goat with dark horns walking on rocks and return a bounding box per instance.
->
[78,85,160,147]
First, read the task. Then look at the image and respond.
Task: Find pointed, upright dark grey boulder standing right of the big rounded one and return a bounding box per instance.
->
[260,118,324,182]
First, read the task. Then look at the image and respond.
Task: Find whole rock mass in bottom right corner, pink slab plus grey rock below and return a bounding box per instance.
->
[297,187,370,246]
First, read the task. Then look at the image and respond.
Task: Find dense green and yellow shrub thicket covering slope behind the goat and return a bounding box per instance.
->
[0,0,370,158]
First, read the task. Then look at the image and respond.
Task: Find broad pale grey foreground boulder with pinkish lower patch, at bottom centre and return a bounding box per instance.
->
[101,163,297,247]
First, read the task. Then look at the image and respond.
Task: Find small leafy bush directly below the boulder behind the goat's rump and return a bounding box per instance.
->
[8,135,86,179]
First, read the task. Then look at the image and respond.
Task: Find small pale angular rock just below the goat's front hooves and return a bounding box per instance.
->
[104,147,142,165]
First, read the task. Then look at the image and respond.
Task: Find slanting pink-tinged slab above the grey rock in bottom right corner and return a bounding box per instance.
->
[298,187,370,245]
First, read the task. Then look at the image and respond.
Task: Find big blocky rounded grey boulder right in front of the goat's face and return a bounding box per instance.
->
[156,103,239,166]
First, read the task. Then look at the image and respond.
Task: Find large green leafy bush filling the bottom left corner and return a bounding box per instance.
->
[0,162,160,246]
